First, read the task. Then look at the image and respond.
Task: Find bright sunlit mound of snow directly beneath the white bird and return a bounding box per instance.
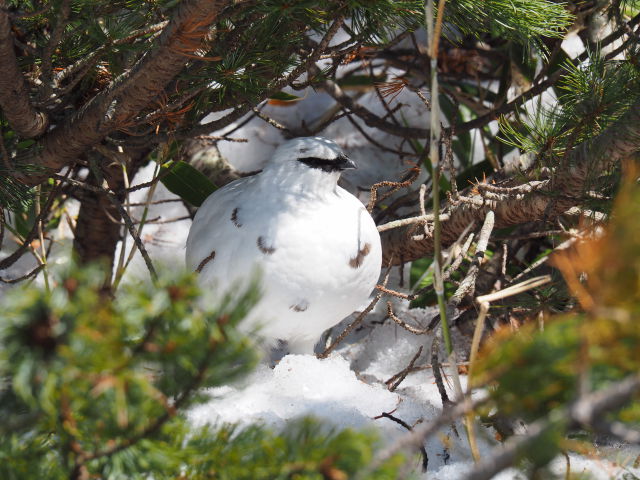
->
[191,354,400,428]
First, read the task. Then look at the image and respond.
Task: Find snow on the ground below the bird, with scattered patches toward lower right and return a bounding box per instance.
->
[189,326,640,480]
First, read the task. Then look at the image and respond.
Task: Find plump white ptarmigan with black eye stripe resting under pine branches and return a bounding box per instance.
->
[186,137,382,353]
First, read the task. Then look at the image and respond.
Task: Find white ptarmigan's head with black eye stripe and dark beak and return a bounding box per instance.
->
[268,137,357,180]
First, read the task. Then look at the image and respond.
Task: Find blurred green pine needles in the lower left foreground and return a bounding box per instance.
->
[0,266,402,480]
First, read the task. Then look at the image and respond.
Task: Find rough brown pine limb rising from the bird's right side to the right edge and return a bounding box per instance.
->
[382,102,640,265]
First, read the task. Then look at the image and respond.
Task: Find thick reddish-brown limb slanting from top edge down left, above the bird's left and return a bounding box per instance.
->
[25,0,240,184]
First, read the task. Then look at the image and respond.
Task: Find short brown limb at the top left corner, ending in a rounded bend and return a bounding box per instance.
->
[0,0,47,138]
